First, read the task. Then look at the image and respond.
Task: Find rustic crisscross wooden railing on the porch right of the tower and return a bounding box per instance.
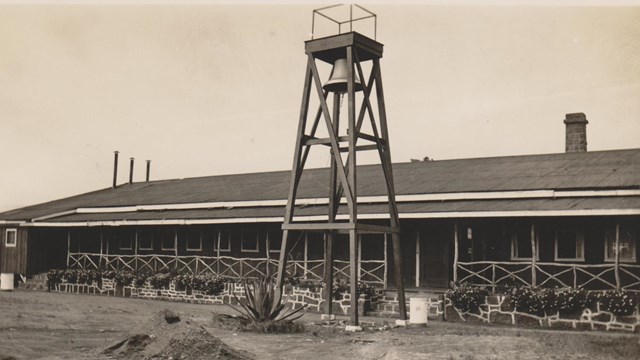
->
[456,261,640,291]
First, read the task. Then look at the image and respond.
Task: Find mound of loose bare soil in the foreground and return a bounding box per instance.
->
[102,310,253,360]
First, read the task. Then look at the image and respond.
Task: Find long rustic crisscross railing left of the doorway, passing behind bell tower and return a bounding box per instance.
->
[69,253,387,287]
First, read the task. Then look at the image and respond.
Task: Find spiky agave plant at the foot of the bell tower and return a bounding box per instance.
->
[228,277,307,332]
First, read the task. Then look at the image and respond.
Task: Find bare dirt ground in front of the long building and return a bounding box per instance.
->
[0,291,640,360]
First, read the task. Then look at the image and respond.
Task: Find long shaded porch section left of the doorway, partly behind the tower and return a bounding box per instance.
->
[58,224,391,288]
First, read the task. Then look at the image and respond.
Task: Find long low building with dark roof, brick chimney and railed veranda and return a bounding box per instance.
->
[0,114,640,290]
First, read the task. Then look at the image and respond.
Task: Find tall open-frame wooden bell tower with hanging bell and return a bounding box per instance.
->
[277,5,406,326]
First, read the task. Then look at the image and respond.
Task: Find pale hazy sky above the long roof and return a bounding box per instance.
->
[0,1,640,211]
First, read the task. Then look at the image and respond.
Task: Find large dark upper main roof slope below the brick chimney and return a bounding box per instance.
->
[0,149,640,220]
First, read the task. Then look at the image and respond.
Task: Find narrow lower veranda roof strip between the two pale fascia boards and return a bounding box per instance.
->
[36,196,640,222]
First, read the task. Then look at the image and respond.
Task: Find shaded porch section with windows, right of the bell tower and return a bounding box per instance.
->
[453,218,640,291]
